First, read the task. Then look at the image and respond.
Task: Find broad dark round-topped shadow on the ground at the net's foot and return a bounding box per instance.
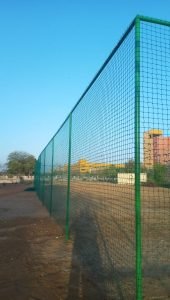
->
[67,210,106,300]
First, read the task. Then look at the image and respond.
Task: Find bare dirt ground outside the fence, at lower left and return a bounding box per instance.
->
[0,184,104,300]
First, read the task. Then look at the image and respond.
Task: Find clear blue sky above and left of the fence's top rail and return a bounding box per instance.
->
[0,0,170,163]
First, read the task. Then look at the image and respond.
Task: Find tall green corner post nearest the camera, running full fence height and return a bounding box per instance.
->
[135,16,142,300]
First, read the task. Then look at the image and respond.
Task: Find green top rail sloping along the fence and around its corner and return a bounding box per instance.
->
[38,15,170,158]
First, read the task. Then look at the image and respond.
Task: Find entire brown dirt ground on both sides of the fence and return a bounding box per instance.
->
[0,183,170,300]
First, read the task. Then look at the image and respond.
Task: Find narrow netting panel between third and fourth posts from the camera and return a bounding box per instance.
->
[44,141,53,210]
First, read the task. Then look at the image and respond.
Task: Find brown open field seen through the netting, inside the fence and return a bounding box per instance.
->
[50,181,170,299]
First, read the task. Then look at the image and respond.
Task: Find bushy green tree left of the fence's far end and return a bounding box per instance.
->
[7,151,36,175]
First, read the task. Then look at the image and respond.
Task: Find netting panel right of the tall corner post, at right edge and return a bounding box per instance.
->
[141,22,170,299]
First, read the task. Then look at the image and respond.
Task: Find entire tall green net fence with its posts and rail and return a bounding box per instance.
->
[35,16,170,300]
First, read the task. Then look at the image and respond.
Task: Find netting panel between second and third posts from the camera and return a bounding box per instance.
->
[52,121,69,228]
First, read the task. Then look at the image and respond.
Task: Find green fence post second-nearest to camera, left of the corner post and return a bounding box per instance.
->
[66,113,72,240]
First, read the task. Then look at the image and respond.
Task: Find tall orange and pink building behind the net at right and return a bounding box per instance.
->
[144,129,170,168]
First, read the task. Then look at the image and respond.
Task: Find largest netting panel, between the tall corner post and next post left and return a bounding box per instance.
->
[70,28,135,299]
